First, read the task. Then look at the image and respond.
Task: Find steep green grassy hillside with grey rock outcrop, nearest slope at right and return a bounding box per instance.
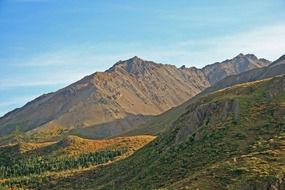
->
[23,76,285,189]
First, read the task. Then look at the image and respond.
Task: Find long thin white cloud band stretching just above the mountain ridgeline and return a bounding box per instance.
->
[3,24,285,89]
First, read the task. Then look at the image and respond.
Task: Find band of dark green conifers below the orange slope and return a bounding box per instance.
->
[0,149,126,178]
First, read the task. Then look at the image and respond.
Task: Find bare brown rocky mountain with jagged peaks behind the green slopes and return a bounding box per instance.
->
[0,54,270,138]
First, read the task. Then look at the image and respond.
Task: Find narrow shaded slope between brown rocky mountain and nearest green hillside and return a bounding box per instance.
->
[115,55,285,136]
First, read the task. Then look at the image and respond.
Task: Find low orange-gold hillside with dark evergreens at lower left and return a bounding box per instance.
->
[0,135,155,189]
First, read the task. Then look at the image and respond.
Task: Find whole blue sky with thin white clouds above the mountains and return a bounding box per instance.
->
[0,0,285,116]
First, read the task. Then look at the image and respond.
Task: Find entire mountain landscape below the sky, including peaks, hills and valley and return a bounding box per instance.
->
[0,54,285,190]
